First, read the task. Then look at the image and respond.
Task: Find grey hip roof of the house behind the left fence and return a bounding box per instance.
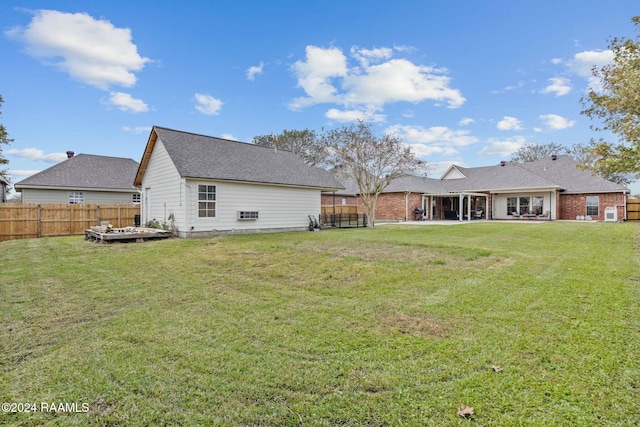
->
[14,154,138,191]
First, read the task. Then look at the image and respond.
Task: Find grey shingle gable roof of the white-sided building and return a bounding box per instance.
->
[135,126,343,190]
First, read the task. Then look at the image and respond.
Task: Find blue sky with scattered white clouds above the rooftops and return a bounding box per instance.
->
[0,0,640,192]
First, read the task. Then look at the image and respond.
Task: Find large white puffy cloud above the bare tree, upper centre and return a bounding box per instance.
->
[289,46,466,111]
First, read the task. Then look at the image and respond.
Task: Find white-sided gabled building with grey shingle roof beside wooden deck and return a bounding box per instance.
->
[134,126,342,237]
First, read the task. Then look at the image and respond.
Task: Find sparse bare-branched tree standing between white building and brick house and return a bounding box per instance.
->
[323,121,424,227]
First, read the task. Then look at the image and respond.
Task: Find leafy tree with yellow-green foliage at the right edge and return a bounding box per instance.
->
[581,16,640,181]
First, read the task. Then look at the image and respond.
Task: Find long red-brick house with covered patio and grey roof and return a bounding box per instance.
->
[322,155,629,221]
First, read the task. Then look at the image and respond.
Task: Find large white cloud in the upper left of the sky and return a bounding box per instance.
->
[5,10,150,89]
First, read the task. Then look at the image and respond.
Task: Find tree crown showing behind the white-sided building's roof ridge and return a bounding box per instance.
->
[253,129,328,166]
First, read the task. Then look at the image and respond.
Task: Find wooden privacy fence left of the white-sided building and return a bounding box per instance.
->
[0,203,140,241]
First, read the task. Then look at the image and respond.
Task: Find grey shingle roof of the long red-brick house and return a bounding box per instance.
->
[332,156,629,195]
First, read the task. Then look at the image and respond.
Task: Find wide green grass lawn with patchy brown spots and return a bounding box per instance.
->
[0,222,640,426]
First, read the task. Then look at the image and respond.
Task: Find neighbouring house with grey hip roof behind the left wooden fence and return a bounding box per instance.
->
[14,151,140,203]
